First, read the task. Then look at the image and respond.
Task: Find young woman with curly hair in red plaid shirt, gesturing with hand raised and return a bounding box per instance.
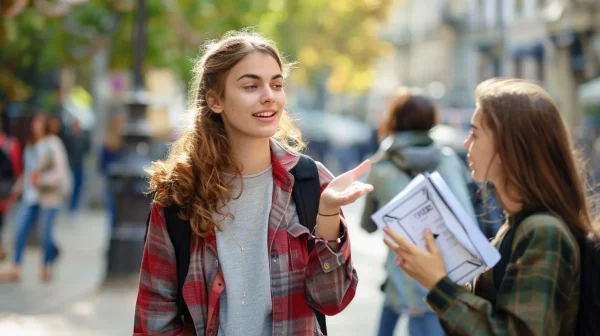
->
[134,33,372,335]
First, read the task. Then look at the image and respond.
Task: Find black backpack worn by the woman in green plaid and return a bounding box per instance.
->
[493,210,600,336]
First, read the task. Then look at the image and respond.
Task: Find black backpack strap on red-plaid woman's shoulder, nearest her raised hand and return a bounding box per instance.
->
[290,155,327,335]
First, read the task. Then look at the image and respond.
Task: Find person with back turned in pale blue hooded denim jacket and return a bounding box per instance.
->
[361,88,474,336]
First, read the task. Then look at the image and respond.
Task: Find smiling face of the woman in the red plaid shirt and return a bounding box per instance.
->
[209,52,286,141]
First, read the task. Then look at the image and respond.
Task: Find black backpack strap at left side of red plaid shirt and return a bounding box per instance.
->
[144,206,192,316]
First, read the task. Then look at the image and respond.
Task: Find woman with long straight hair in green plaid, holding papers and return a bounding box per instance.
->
[386,79,598,336]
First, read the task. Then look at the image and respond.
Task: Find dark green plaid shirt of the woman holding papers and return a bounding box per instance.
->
[427,215,580,336]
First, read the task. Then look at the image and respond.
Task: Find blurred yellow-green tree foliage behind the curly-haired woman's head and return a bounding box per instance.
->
[112,0,394,93]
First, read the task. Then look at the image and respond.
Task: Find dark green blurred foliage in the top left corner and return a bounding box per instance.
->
[0,0,126,109]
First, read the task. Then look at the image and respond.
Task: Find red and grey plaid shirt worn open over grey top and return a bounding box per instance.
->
[134,142,358,336]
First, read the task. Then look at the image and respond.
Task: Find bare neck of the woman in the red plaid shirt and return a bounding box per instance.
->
[229,138,271,175]
